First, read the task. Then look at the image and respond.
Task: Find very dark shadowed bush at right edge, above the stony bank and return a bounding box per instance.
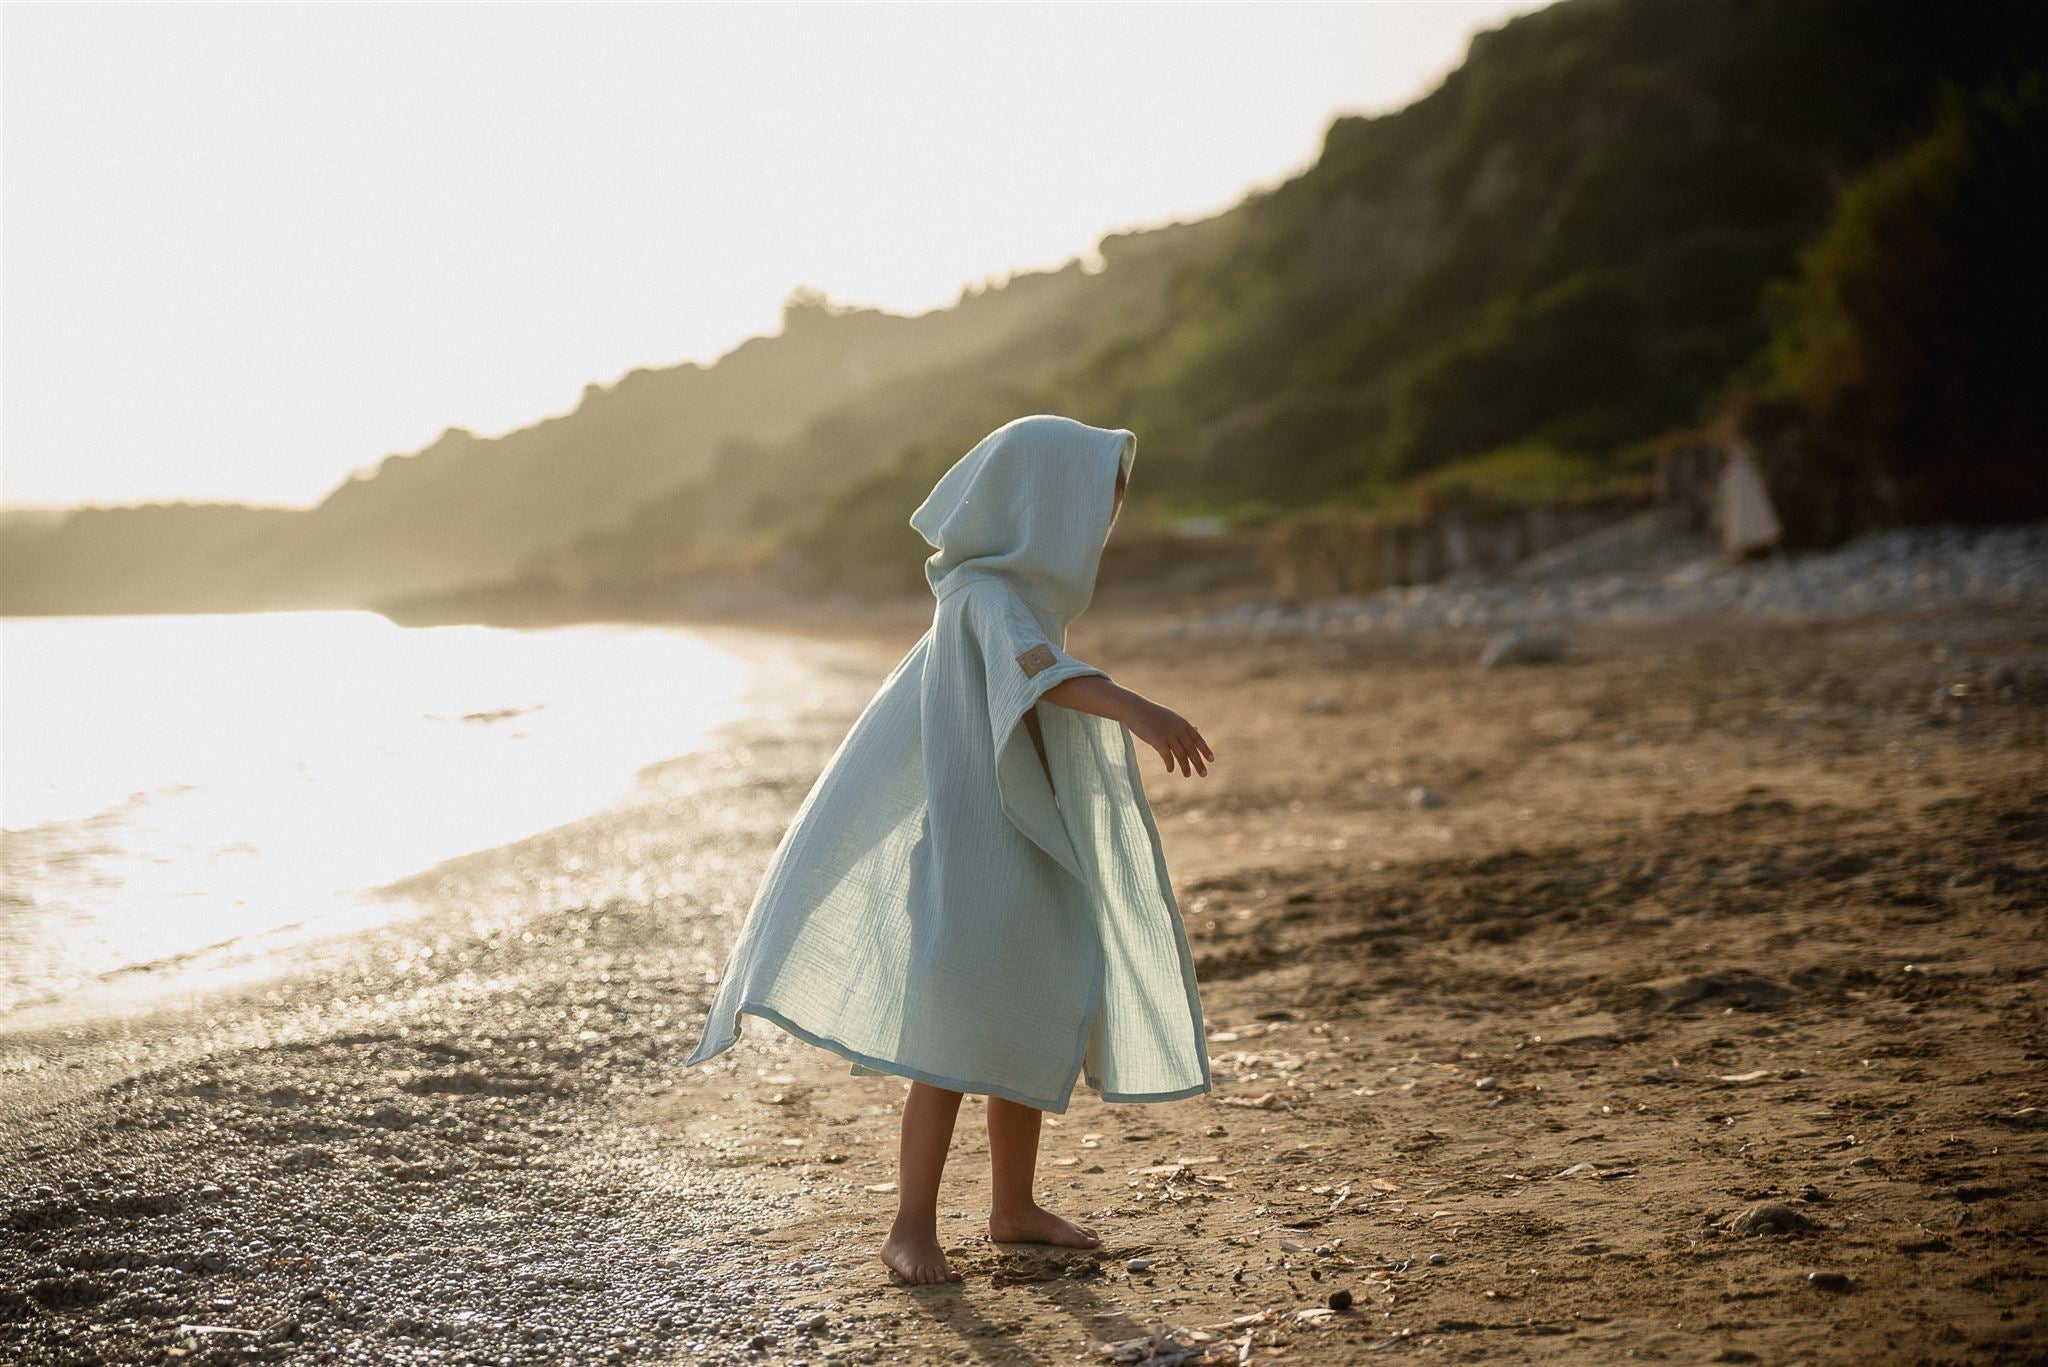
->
[1745,72,2048,541]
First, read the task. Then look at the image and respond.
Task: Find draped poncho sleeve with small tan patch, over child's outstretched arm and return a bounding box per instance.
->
[961,578,1110,879]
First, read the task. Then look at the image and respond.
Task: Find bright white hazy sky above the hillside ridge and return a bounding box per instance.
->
[0,0,1542,506]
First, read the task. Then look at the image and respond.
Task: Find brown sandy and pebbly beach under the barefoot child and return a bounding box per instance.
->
[0,609,2048,1363]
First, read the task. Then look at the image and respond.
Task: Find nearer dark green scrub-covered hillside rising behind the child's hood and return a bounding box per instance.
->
[761,0,2044,582]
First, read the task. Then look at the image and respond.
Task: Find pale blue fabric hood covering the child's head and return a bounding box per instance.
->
[909,414,1139,625]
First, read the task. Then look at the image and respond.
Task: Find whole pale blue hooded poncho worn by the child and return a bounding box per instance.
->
[686,414,1208,1113]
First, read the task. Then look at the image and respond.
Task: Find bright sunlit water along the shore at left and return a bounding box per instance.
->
[0,611,748,1019]
